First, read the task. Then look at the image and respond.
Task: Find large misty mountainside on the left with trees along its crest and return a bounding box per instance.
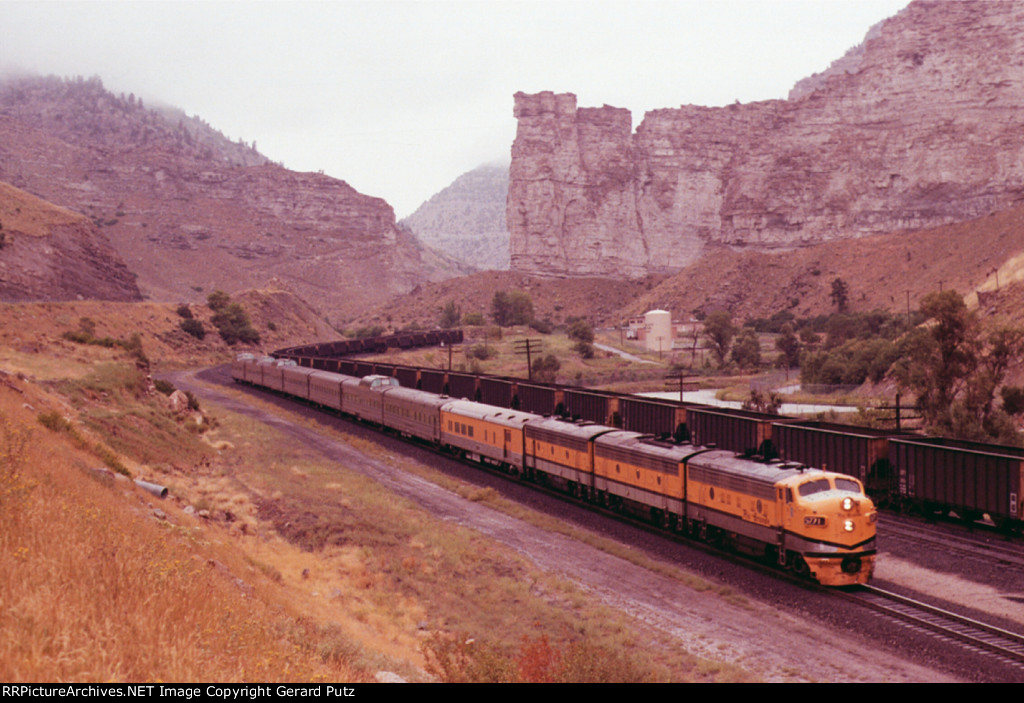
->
[0,78,461,318]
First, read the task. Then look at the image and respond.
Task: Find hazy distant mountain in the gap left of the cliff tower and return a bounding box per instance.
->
[401,164,509,270]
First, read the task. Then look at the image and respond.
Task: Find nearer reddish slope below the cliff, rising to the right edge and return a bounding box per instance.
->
[621,206,1024,319]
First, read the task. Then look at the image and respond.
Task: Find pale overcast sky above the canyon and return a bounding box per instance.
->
[0,0,907,219]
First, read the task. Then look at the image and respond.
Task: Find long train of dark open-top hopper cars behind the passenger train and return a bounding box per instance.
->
[274,347,1024,532]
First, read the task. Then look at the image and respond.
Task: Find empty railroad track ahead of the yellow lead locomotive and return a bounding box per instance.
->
[841,585,1024,671]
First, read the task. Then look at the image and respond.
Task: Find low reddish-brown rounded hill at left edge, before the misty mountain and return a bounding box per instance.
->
[0,182,141,303]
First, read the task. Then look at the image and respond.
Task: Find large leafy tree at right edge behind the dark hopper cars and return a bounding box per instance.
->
[891,291,1024,444]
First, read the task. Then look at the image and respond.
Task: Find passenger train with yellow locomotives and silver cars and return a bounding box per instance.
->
[231,355,877,585]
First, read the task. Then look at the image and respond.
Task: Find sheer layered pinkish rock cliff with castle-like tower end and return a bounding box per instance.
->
[507,1,1024,277]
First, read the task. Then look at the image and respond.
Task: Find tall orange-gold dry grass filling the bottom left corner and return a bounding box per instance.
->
[0,386,366,682]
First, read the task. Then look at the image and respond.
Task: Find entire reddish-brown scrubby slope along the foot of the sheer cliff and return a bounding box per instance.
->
[353,200,1024,328]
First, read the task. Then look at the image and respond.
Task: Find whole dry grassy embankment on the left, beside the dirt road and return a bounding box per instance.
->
[0,304,753,682]
